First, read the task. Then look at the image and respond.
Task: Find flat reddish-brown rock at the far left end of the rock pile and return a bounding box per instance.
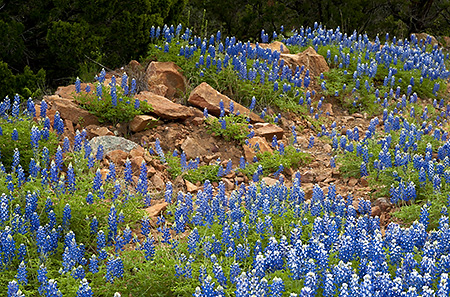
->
[45,95,99,127]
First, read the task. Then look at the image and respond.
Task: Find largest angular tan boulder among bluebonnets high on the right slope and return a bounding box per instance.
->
[281,47,330,77]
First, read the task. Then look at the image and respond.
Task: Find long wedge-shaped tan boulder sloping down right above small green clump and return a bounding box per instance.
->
[188,82,263,123]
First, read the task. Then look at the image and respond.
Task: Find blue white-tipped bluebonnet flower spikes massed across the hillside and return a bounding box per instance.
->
[0,25,450,297]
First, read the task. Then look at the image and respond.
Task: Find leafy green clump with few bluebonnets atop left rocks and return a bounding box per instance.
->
[74,85,152,125]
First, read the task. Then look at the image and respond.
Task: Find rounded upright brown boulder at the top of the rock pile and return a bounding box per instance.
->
[146,62,186,99]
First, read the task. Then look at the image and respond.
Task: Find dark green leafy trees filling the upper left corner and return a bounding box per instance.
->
[0,0,187,92]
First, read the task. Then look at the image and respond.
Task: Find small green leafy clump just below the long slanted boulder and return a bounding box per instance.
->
[206,114,249,144]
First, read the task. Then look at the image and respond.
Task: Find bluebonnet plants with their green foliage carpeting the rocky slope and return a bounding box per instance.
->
[0,21,450,297]
